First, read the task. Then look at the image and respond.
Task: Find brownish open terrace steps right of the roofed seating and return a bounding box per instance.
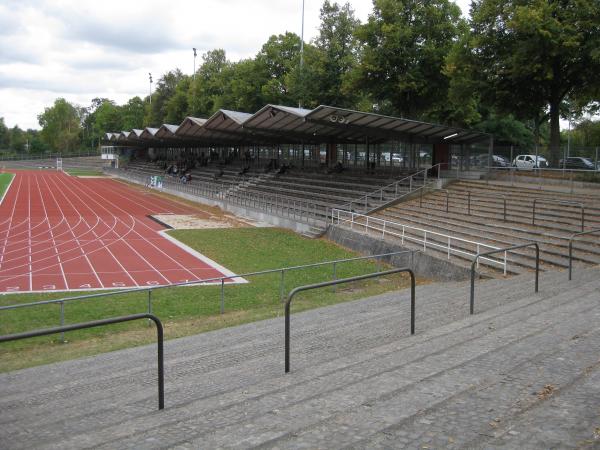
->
[374,181,600,273]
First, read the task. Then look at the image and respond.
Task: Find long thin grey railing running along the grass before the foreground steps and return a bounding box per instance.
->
[0,250,416,326]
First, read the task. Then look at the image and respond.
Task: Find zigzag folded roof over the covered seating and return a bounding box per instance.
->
[107,105,491,145]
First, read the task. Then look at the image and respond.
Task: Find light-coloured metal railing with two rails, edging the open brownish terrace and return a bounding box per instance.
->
[331,208,507,275]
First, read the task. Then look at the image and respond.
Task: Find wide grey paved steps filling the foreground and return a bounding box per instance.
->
[0,268,600,449]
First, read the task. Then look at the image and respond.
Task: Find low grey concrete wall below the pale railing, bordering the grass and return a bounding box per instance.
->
[325,225,471,281]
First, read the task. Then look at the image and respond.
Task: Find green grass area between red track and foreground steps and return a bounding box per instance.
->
[0,228,418,371]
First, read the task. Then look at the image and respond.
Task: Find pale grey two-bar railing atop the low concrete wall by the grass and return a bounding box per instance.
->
[332,208,507,268]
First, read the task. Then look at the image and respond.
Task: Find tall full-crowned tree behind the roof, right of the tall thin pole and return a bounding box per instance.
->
[353,0,461,119]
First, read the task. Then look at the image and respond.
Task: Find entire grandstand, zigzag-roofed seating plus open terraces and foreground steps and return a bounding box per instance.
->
[0,105,600,448]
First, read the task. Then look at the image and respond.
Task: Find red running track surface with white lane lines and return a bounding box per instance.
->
[0,171,239,293]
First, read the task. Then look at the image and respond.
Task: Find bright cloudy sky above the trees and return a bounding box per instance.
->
[0,0,470,129]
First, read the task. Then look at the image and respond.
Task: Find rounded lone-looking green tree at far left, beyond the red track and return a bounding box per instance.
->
[38,98,81,151]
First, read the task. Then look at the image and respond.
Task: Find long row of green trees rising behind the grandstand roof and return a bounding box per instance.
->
[10,0,600,158]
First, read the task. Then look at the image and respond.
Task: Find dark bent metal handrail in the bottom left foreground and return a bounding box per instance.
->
[0,314,165,409]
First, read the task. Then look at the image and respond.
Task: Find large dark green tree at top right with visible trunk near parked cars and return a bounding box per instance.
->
[472,0,600,163]
